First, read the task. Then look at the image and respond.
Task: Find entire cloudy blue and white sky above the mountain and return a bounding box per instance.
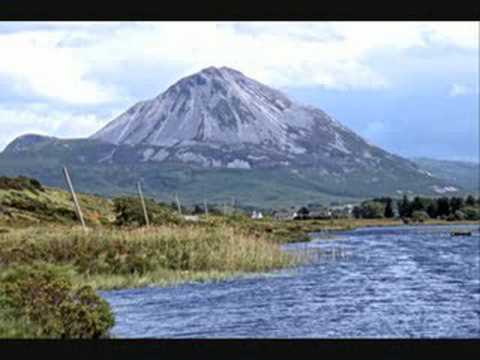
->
[0,21,480,161]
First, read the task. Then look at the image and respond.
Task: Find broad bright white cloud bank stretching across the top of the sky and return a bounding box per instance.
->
[0,22,478,104]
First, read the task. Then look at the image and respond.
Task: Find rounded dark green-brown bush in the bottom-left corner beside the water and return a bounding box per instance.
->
[0,263,114,338]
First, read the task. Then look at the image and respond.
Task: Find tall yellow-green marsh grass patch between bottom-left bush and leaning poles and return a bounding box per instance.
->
[0,225,299,288]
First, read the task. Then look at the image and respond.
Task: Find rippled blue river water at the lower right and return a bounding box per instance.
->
[101,225,480,338]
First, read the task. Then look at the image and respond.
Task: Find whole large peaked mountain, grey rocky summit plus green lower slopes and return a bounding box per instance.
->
[0,67,462,206]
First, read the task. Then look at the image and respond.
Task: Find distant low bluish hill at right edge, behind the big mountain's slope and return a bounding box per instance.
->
[412,158,480,194]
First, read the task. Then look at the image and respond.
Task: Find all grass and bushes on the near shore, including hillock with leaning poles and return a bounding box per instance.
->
[0,177,478,338]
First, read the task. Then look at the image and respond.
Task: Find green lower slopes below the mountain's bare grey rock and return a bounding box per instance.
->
[0,137,466,209]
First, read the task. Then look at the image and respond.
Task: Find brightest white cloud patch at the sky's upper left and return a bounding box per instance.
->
[0,30,121,104]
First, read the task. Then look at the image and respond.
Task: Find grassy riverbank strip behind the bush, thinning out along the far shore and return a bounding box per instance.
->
[0,216,477,290]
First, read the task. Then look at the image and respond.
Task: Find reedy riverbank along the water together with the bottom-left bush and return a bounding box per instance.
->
[0,216,476,337]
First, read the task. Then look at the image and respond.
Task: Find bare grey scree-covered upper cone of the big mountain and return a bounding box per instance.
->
[92,67,419,173]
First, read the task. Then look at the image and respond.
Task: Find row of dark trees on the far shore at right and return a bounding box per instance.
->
[353,195,480,221]
